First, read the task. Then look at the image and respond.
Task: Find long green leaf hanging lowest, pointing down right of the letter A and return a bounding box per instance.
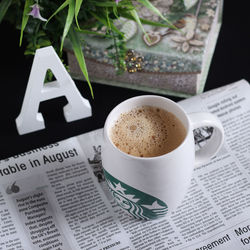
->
[69,27,94,98]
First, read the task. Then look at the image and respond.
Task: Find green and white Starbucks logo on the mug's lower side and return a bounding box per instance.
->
[104,170,168,220]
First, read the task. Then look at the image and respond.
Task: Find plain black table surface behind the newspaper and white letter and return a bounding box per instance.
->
[0,1,250,159]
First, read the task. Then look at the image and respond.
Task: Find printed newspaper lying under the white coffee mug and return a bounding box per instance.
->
[0,80,250,250]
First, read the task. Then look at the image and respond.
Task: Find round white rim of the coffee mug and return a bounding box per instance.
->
[103,95,191,161]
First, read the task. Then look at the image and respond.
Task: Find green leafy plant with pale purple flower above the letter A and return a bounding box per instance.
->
[0,0,175,96]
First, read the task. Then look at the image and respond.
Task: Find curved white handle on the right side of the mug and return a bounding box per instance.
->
[188,112,224,166]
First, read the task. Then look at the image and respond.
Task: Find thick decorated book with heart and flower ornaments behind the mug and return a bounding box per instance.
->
[66,0,223,97]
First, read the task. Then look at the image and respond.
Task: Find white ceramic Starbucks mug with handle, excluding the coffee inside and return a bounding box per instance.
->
[102,95,224,219]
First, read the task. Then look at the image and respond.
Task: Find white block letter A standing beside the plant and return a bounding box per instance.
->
[16,46,92,134]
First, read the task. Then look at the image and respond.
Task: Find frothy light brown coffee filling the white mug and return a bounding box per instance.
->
[110,106,186,157]
